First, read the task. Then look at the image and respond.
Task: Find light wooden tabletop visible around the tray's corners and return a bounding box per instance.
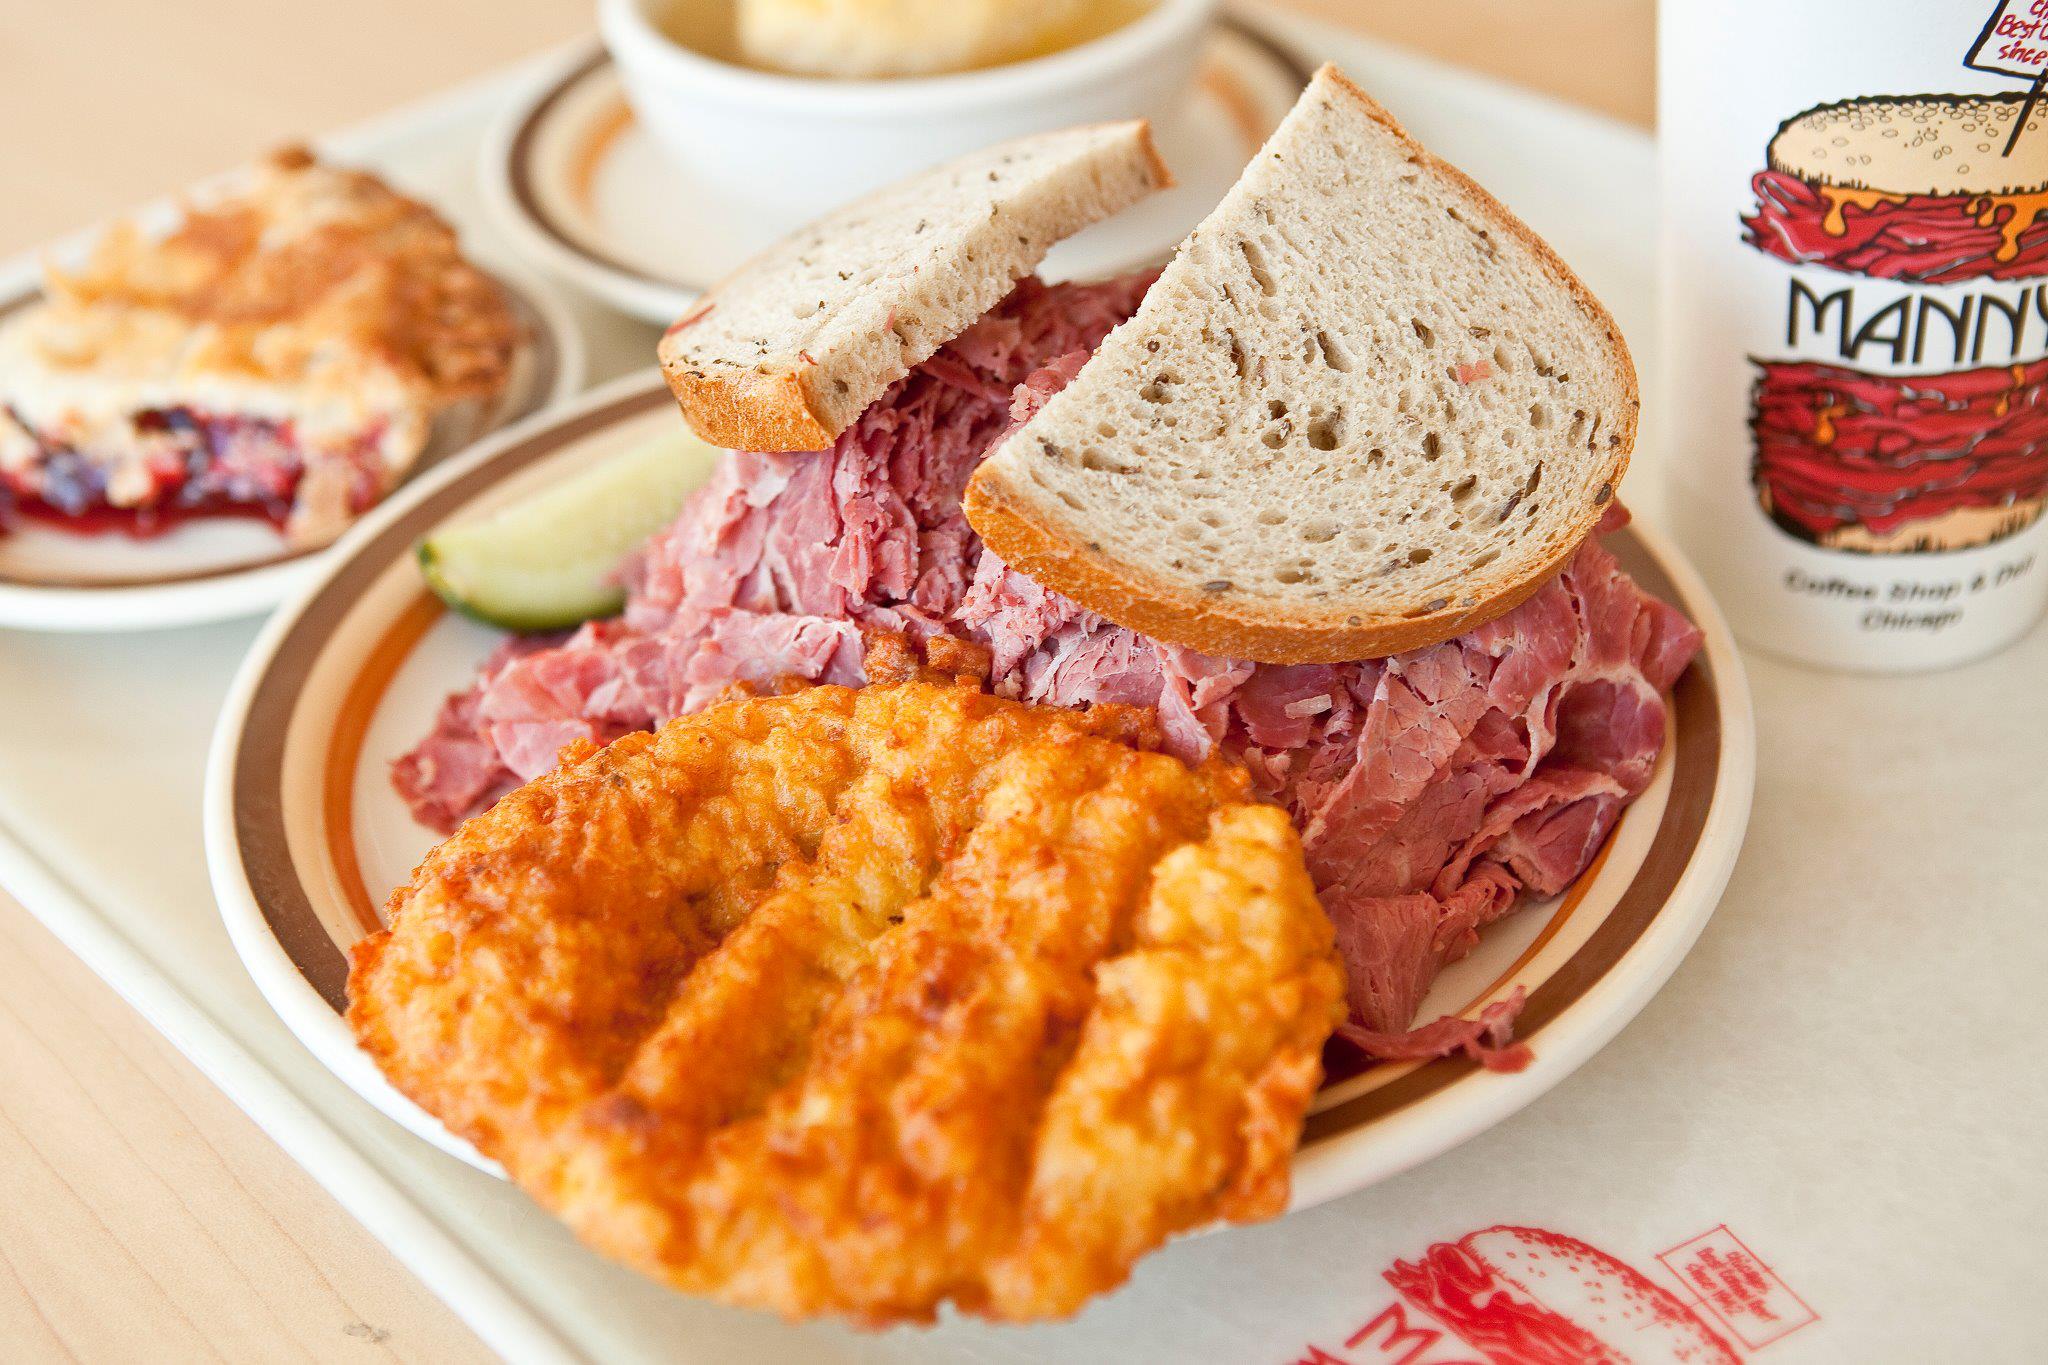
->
[0,0,1653,1363]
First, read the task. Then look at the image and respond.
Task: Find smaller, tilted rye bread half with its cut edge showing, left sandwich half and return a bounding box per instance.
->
[657,119,1174,450]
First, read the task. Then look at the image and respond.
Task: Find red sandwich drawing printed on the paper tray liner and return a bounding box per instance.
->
[1386,1226,1741,1365]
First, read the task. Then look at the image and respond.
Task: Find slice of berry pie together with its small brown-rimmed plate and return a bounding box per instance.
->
[0,147,580,628]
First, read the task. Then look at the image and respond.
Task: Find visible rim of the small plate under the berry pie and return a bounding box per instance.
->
[0,263,584,630]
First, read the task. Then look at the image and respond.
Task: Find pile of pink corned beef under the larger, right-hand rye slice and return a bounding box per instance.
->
[961,507,1700,1064]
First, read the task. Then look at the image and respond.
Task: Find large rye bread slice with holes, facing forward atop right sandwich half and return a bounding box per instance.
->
[967,65,1640,663]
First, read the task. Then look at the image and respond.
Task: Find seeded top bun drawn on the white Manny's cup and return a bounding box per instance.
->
[1769,92,2048,196]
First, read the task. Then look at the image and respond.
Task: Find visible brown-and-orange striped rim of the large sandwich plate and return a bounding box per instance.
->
[205,370,1755,1205]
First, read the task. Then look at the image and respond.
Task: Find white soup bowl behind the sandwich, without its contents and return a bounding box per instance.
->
[598,0,1219,241]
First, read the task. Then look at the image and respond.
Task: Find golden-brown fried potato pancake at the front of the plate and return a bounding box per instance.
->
[348,646,1343,1324]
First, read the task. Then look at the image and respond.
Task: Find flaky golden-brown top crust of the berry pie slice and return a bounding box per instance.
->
[43,149,524,403]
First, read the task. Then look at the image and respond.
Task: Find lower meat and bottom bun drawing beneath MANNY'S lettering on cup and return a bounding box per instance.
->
[1751,351,2048,555]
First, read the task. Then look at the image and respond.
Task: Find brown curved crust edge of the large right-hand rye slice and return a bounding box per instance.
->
[965,65,1642,663]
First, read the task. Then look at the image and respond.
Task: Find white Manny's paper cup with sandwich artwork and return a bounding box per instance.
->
[1659,0,2048,669]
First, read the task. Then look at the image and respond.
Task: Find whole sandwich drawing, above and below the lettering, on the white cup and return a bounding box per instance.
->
[1743,92,2048,555]
